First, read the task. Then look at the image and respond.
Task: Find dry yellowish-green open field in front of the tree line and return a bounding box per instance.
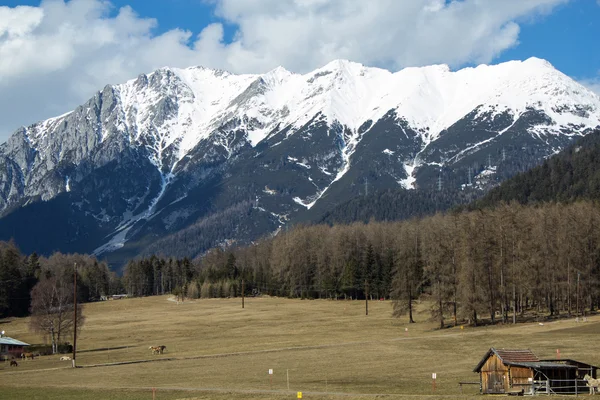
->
[0,296,600,400]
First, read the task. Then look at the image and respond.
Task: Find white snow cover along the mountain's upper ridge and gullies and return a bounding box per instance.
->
[0,58,600,219]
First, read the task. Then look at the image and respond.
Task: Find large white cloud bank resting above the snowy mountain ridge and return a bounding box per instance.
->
[0,0,569,140]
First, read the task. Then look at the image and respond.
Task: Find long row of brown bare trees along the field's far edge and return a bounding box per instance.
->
[124,201,600,327]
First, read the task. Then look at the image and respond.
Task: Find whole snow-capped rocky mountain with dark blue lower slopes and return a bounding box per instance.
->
[0,58,600,264]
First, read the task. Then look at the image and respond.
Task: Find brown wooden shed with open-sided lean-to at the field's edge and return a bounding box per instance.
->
[474,348,598,394]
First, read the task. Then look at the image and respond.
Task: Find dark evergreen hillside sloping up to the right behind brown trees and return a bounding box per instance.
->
[474,130,600,207]
